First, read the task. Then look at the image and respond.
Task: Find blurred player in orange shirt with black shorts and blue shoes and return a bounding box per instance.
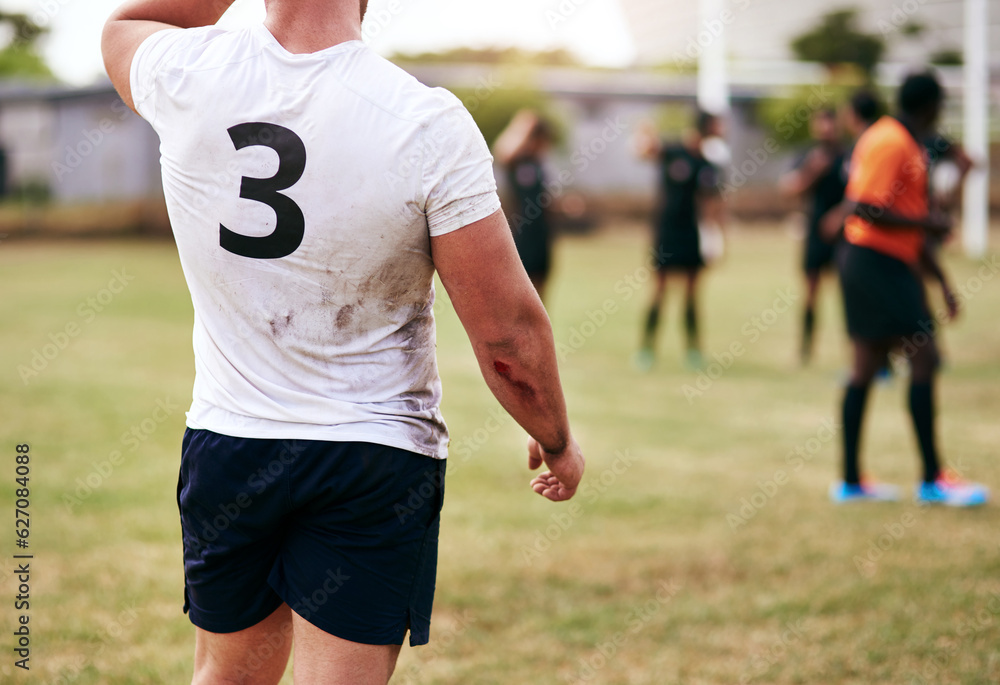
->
[830,73,987,506]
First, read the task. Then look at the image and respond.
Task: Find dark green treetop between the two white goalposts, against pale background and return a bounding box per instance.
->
[791,9,885,77]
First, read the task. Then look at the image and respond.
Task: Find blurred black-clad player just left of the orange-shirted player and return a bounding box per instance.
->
[780,109,847,364]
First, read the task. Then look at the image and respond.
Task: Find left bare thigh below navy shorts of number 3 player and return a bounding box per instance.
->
[191,604,292,685]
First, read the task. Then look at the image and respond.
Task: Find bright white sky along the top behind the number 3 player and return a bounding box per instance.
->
[0,0,635,84]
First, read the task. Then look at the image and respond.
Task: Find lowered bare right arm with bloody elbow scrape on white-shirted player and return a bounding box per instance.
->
[431,211,583,501]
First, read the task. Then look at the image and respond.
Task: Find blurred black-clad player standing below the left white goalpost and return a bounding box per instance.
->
[635,112,724,370]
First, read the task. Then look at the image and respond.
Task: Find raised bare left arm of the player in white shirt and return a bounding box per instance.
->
[101,0,233,111]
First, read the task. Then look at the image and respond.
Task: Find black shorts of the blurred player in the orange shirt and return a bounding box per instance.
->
[838,243,934,340]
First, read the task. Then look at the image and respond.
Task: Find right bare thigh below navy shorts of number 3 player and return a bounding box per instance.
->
[292,614,402,685]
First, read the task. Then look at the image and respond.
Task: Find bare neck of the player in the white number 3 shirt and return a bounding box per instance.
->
[264,0,361,54]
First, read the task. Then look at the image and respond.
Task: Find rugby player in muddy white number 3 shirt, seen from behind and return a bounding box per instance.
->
[102,0,583,685]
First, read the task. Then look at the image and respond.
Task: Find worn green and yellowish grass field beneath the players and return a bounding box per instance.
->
[0,227,1000,685]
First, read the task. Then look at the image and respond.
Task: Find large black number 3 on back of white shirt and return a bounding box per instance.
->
[219,122,306,259]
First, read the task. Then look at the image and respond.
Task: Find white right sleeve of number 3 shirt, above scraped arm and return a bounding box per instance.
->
[422,97,500,236]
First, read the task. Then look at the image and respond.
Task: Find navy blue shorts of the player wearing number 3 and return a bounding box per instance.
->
[177,429,445,646]
